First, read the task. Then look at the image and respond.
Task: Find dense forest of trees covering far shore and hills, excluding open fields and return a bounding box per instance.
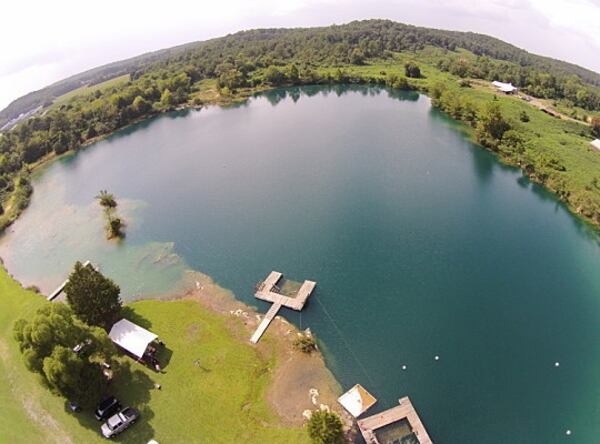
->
[0,20,600,226]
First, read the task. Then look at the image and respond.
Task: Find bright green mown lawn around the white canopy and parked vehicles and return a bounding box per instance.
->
[0,269,308,444]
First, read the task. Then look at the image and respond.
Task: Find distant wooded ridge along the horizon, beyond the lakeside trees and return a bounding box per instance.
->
[0,20,600,128]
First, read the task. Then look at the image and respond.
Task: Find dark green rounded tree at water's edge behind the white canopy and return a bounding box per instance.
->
[65,262,122,331]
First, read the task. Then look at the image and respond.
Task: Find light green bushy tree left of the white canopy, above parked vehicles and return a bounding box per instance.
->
[13,303,120,408]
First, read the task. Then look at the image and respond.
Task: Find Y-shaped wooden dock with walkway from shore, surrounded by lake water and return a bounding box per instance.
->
[250,271,317,344]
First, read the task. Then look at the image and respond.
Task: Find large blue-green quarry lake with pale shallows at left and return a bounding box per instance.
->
[0,87,600,444]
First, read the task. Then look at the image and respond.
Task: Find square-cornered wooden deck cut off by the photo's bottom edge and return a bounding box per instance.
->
[358,396,433,444]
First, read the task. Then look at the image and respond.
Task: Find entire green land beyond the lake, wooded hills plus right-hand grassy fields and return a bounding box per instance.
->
[0,20,600,229]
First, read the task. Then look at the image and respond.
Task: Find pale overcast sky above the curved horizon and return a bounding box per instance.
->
[0,0,600,109]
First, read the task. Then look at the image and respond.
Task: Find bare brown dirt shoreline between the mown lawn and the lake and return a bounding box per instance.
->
[0,259,356,436]
